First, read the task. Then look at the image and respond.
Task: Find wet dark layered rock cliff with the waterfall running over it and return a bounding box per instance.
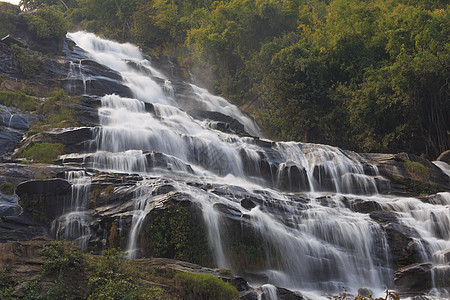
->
[0,17,450,299]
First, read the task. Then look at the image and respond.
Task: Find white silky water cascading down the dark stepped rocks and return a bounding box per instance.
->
[63,32,450,299]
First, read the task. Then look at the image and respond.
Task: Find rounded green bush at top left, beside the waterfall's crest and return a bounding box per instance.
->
[25,6,68,39]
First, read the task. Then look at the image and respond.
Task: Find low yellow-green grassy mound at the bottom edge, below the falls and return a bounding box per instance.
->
[175,273,239,300]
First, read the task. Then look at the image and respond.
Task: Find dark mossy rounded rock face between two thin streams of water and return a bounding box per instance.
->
[142,204,212,266]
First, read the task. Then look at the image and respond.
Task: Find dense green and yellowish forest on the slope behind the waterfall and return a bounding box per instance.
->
[11,0,450,159]
